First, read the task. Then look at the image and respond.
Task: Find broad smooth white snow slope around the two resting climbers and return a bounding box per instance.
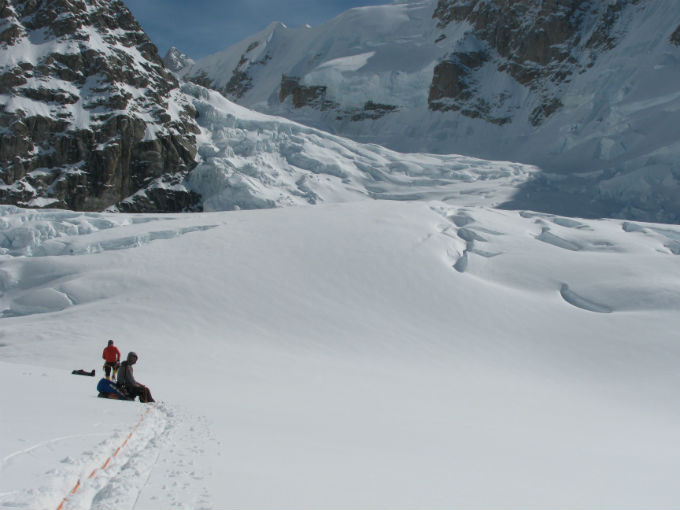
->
[0,200,680,509]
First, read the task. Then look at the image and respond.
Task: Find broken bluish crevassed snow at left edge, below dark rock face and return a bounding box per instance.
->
[0,206,215,317]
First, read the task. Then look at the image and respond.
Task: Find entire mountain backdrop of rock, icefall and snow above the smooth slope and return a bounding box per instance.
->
[0,0,680,222]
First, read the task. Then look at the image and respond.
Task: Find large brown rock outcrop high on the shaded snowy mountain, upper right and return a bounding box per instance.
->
[428,0,648,126]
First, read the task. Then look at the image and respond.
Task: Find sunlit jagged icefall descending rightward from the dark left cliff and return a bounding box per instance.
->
[183,84,537,211]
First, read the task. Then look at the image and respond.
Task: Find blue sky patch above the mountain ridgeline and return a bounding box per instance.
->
[123,0,390,59]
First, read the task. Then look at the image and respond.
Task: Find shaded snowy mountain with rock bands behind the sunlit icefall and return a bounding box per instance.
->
[181,0,680,221]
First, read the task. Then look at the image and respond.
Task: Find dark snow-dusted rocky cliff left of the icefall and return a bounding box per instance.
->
[0,0,200,211]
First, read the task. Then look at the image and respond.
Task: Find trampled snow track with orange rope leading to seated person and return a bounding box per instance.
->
[0,401,216,510]
